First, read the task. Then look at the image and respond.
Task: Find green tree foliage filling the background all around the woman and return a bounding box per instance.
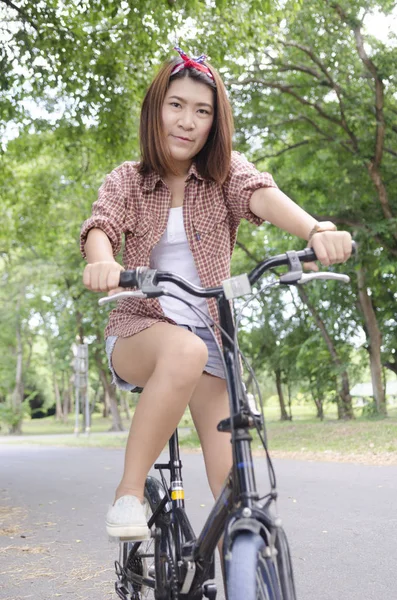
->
[0,0,397,432]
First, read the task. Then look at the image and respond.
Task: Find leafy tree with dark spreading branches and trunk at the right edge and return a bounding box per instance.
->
[204,0,397,413]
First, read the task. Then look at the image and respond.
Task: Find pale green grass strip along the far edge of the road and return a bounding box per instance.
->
[2,403,397,464]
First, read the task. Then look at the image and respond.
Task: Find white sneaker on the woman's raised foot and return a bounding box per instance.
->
[106,496,150,540]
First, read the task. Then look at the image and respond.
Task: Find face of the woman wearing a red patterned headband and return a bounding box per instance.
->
[162,77,214,173]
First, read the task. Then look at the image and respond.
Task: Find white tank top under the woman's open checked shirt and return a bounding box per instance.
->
[150,206,209,327]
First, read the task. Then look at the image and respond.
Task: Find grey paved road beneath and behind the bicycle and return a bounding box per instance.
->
[0,445,397,600]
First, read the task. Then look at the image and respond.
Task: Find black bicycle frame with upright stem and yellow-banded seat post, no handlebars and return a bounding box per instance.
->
[139,294,266,597]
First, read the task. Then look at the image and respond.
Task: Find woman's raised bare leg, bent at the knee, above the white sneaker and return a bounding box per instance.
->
[112,323,208,501]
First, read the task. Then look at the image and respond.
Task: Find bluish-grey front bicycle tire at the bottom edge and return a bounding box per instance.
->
[226,531,282,600]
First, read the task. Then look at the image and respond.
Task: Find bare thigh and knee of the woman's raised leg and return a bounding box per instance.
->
[112,323,208,387]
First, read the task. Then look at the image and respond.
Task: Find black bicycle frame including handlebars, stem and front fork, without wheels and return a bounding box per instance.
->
[110,248,349,600]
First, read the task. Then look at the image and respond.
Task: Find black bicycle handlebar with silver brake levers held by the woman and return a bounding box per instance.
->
[99,242,357,305]
